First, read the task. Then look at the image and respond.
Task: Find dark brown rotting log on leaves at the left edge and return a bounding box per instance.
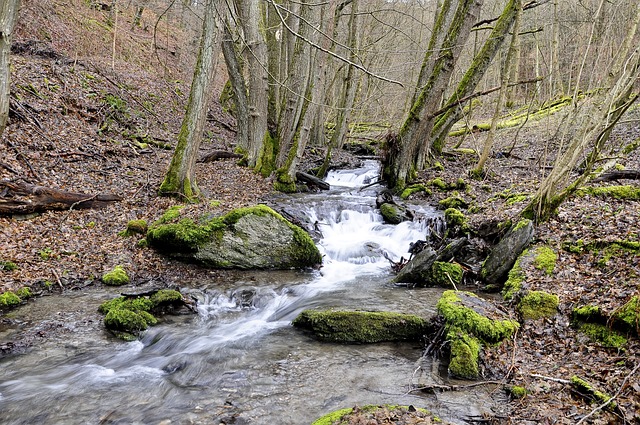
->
[0,180,122,215]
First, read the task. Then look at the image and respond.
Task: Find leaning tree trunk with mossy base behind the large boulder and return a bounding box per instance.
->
[159,0,222,201]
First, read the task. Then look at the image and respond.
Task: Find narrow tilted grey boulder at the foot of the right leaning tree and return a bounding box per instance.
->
[480,219,533,284]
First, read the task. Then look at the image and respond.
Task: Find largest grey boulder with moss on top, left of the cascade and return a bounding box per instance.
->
[147,205,322,269]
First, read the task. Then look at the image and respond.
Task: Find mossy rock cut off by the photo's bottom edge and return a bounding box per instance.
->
[311,405,448,425]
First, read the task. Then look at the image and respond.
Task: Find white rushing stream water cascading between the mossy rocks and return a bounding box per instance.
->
[0,162,500,425]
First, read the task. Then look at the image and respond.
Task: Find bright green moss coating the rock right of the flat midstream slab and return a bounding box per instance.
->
[437,291,519,344]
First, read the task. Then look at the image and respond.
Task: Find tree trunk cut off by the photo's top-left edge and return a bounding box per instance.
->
[0,0,20,136]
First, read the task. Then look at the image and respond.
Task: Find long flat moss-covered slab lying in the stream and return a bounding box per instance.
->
[292,310,429,343]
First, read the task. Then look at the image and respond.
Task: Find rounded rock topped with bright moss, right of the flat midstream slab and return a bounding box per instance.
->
[437,290,519,345]
